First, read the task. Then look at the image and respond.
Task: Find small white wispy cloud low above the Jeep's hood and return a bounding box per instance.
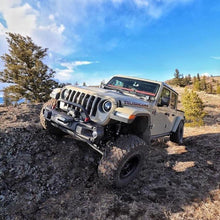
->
[55,61,97,83]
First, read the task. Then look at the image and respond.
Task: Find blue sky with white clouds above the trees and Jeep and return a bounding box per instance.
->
[0,0,220,93]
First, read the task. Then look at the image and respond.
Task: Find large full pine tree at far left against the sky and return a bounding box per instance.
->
[0,33,58,102]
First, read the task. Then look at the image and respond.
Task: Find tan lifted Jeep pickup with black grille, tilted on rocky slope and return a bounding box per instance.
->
[40,76,184,187]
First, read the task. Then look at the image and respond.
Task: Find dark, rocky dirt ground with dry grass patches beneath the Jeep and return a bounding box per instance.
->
[0,104,220,220]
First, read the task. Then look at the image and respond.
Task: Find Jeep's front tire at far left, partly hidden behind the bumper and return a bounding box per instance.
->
[40,99,64,136]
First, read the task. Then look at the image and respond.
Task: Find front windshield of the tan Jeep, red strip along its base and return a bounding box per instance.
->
[106,77,160,97]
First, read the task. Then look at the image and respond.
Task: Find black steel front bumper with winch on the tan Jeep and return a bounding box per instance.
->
[44,107,104,143]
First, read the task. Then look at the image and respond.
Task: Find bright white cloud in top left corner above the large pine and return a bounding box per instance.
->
[0,0,69,54]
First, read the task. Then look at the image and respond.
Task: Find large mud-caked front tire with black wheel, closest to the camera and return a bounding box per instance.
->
[98,135,147,187]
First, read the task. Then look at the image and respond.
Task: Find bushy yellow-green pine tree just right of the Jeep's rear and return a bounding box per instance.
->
[181,89,205,126]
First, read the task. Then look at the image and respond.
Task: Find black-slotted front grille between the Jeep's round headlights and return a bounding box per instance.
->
[63,90,101,116]
